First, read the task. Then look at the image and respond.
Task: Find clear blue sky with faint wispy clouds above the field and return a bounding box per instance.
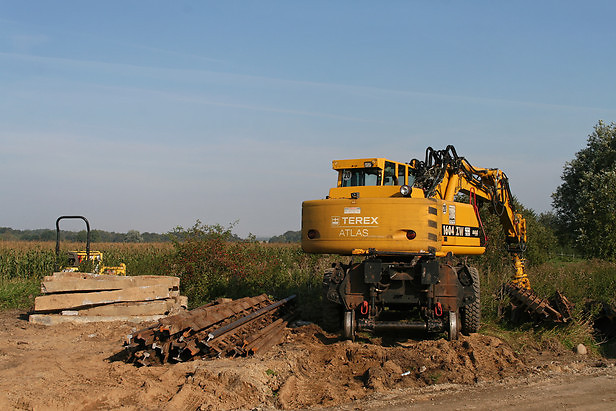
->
[0,1,616,236]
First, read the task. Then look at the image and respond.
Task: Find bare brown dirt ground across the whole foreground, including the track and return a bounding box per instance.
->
[0,312,616,410]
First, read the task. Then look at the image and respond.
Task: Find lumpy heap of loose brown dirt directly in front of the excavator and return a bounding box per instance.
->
[244,325,526,408]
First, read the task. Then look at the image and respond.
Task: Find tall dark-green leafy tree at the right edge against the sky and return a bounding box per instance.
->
[552,121,616,259]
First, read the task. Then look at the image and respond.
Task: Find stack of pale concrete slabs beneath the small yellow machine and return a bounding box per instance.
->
[30,272,187,325]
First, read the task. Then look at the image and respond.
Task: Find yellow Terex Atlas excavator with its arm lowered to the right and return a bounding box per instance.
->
[302,145,566,340]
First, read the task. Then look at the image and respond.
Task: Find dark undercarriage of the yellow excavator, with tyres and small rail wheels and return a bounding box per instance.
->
[323,254,480,339]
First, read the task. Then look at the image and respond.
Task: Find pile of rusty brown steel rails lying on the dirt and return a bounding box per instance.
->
[125,294,295,366]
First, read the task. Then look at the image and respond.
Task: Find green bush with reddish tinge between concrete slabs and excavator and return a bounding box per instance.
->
[170,221,330,319]
